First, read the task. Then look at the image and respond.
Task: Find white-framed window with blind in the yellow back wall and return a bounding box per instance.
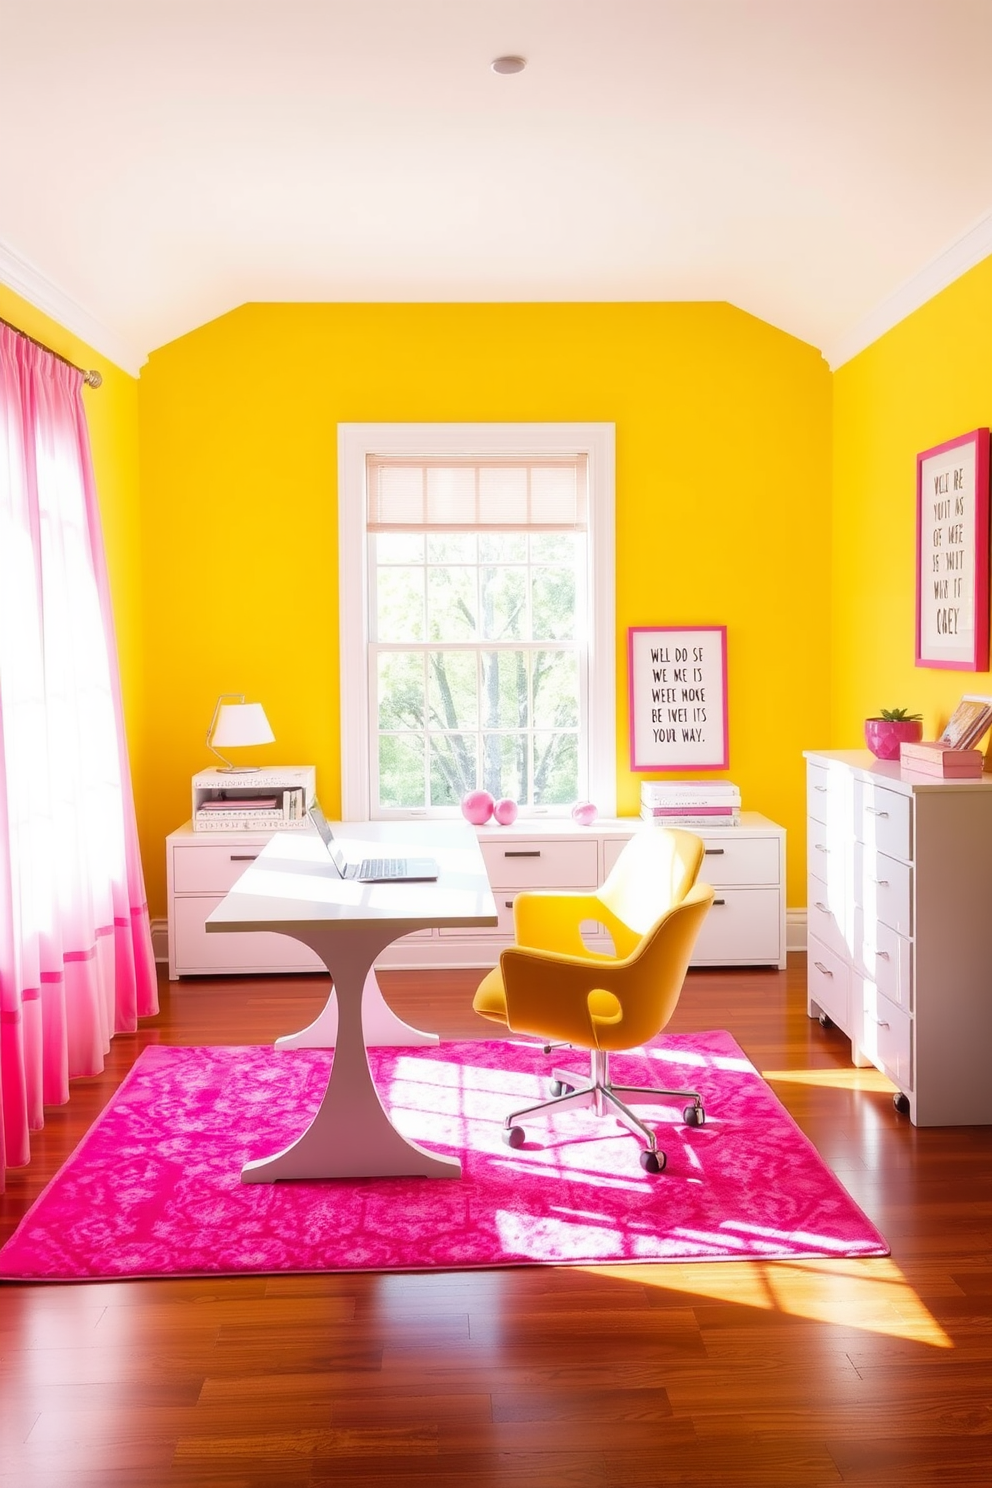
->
[339,424,616,818]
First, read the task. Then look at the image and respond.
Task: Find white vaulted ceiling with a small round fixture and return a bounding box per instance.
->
[0,0,992,368]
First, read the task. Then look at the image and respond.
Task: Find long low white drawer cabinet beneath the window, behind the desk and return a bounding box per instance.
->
[167,811,785,978]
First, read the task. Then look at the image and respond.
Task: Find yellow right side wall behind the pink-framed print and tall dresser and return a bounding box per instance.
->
[830,259,992,748]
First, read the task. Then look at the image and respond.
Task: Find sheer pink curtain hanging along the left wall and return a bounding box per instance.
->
[0,324,158,1187]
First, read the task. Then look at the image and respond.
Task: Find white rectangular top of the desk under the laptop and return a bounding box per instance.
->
[207,821,497,934]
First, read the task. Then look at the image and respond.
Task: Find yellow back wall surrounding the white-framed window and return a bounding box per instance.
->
[138,304,831,915]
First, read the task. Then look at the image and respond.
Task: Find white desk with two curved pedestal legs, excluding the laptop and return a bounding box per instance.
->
[205,821,497,1183]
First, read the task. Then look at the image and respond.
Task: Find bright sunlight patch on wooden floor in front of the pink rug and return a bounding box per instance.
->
[582,1257,953,1348]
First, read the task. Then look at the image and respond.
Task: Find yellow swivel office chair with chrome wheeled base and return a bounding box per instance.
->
[473,827,712,1173]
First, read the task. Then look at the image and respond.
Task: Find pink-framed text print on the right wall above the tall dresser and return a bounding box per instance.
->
[916,429,989,671]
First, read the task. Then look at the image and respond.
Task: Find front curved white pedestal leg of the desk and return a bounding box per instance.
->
[241,933,461,1183]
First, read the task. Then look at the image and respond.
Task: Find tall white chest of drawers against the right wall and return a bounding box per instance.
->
[806,750,992,1126]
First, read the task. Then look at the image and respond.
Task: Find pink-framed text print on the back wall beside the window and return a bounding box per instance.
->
[628,625,730,771]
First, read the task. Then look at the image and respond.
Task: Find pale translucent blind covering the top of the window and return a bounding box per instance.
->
[366,454,589,533]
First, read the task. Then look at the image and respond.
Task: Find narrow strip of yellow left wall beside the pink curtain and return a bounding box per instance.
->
[0,284,145,803]
